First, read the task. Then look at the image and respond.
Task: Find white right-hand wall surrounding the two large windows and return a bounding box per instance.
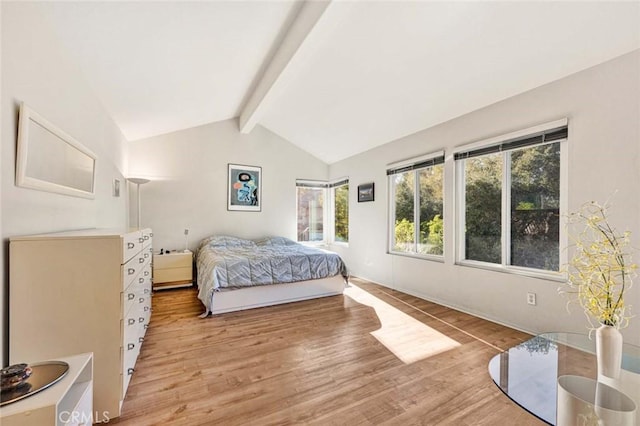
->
[330,51,640,344]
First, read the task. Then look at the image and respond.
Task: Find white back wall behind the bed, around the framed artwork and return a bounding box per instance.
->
[129,119,329,250]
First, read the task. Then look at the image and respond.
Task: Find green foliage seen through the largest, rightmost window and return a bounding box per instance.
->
[465,143,560,270]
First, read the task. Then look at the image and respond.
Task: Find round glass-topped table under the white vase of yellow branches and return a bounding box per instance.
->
[489,333,640,425]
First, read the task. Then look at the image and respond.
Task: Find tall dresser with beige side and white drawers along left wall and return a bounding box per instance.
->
[9,229,153,418]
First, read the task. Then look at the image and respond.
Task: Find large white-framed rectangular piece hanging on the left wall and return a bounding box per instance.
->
[16,103,97,199]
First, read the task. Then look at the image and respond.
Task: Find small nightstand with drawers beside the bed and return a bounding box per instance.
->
[153,251,193,290]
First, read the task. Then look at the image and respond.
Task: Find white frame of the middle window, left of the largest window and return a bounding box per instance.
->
[387,151,447,263]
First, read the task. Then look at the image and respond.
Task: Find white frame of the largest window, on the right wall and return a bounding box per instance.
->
[453,118,569,281]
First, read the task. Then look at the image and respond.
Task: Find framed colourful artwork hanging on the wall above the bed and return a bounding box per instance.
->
[227,163,262,212]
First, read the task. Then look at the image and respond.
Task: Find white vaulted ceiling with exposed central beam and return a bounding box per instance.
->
[39,0,640,163]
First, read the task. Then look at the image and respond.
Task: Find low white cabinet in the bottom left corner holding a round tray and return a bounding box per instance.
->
[0,354,93,426]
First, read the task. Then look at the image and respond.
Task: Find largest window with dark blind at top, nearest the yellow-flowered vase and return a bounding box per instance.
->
[454,122,568,271]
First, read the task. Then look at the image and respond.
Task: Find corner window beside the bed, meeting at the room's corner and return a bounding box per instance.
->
[296,179,349,243]
